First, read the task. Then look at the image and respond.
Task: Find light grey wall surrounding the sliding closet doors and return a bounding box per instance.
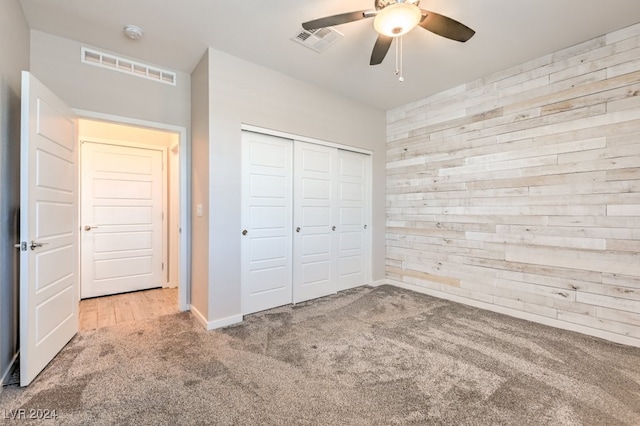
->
[194,49,385,326]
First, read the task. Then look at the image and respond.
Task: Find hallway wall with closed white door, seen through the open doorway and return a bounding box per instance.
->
[78,118,186,310]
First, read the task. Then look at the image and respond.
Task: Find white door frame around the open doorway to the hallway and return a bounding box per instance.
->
[74,109,191,311]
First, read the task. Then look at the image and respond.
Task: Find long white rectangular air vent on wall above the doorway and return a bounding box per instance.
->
[80,47,176,86]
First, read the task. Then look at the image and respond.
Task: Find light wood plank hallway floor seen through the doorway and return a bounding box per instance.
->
[80,288,178,331]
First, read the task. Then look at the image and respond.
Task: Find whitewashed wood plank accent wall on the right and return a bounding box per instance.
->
[386,24,640,346]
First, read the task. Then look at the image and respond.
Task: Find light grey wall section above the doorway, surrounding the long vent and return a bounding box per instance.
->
[31,30,191,128]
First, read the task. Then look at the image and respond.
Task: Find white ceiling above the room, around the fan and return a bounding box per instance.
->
[20,0,640,109]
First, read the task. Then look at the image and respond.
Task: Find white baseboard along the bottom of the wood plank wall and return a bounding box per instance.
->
[387,280,640,347]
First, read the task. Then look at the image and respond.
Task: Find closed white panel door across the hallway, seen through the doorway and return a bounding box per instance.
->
[80,142,164,298]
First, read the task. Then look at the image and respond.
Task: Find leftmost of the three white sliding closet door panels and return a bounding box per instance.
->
[241,132,293,314]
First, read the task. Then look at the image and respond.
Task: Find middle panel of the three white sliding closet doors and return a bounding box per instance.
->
[293,141,339,303]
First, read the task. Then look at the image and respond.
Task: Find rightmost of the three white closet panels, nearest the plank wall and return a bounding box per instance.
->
[337,150,371,291]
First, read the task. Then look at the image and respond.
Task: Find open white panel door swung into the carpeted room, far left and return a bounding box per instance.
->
[20,71,78,386]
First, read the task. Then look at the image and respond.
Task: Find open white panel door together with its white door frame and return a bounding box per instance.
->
[16,71,190,386]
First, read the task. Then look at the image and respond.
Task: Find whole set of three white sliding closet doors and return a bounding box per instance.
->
[240,132,371,314]
